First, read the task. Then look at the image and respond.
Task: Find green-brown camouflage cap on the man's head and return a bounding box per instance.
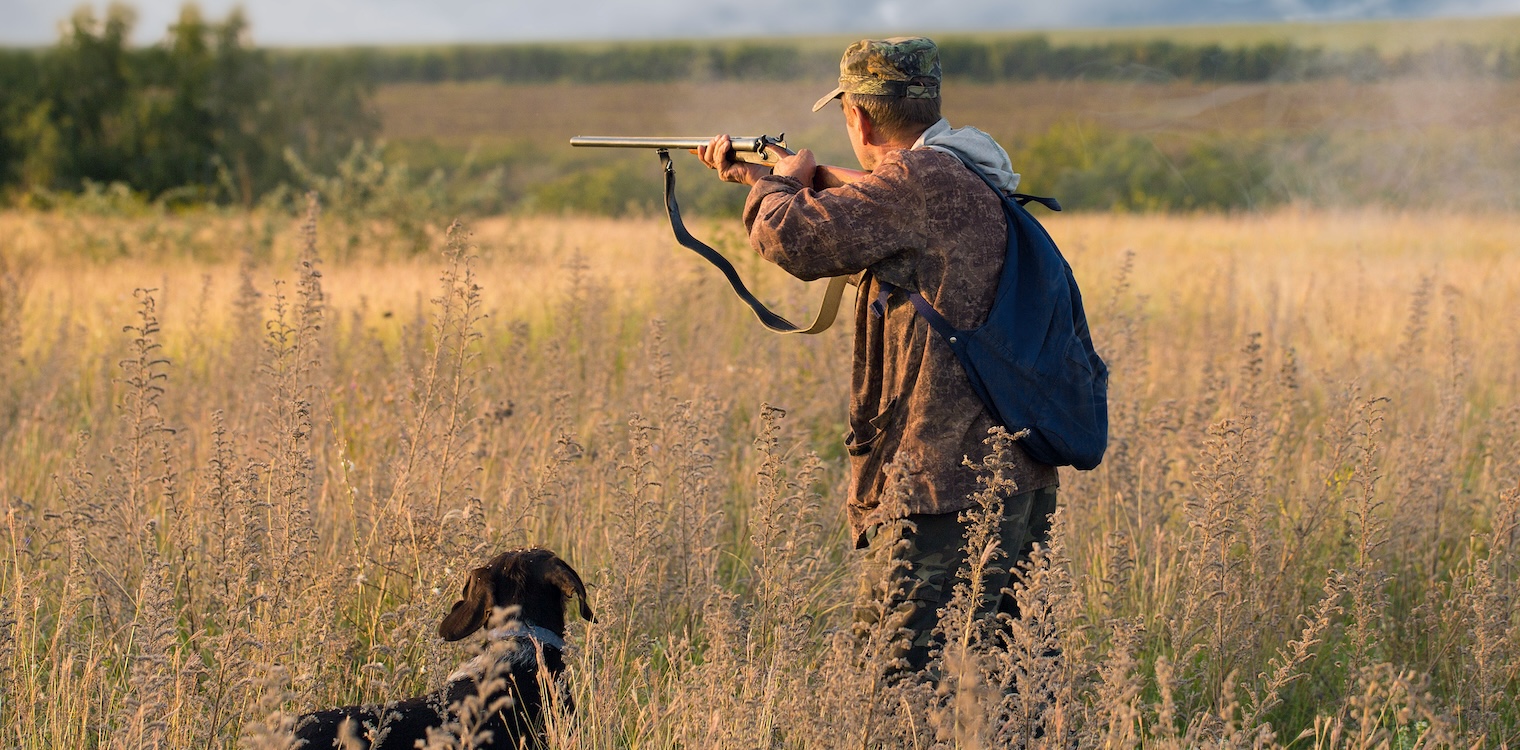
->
[813,37,939,113]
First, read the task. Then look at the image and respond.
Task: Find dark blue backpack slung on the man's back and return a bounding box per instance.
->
[883,158,1108,470]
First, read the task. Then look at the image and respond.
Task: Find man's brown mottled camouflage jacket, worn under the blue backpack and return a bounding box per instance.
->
[745,149,1056,546]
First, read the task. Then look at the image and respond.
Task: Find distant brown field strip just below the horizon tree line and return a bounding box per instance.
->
[375,73,1520,146]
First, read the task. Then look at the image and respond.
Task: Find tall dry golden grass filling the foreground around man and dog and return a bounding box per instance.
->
[0,207,1520,748]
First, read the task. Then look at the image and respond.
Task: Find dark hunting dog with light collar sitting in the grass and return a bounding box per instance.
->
[292,548,596,750]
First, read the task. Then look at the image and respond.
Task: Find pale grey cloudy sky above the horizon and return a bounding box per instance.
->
[0,0,1520,46]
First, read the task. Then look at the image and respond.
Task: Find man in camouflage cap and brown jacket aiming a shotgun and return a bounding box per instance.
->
[698,38,1056,672]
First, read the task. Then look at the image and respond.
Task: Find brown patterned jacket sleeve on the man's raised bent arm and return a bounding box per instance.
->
[745,154,927,281]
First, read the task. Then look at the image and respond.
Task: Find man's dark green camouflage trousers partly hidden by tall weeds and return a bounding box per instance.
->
[854,487,1056,675]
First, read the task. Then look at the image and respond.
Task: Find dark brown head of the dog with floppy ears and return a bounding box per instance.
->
[438,548,596,640]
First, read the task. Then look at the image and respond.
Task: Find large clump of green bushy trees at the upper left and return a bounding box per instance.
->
[0,5,378,205]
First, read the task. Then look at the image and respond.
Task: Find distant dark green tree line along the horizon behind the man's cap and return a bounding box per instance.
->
[289,35,1520,84]
